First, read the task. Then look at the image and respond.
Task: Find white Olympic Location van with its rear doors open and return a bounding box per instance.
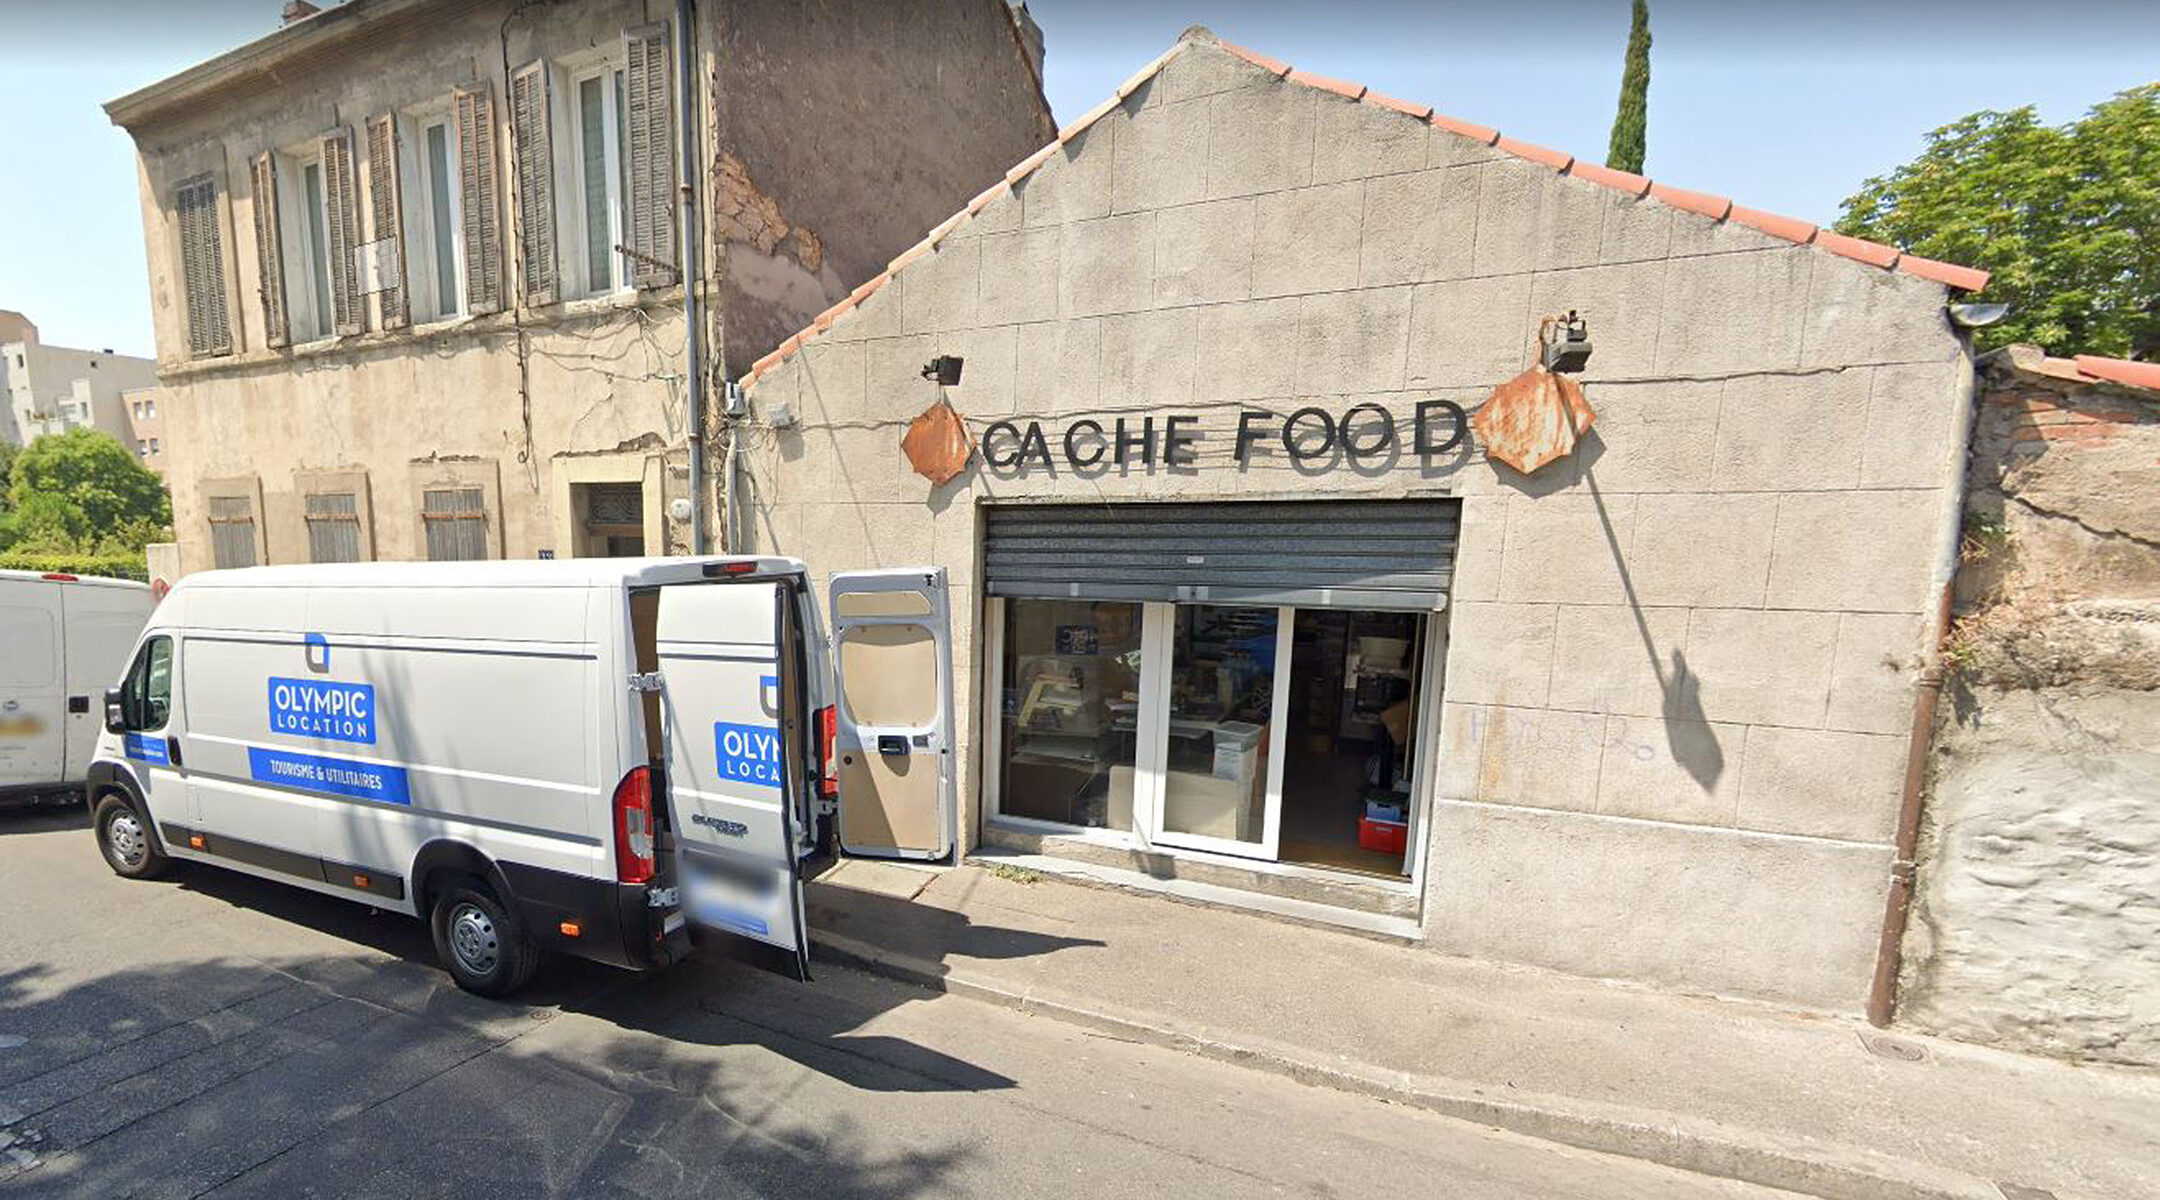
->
[91,557,957,995]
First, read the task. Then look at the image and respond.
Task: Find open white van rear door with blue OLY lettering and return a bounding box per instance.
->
[642,576,810,978]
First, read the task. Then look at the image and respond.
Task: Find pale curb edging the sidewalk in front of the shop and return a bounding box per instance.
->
[810,930,2002,1200]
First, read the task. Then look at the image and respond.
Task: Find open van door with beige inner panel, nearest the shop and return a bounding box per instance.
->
[827,568,959,859]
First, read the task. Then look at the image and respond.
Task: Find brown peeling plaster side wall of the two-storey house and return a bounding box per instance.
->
[713,0,1056,378]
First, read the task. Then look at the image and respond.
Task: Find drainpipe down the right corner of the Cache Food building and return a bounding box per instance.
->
[1868,332,1979,1029]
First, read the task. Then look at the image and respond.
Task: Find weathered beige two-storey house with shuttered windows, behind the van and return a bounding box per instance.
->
[108,0,1050,570]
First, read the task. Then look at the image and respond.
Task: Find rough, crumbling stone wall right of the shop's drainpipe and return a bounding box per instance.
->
[1899,347,2160,1064]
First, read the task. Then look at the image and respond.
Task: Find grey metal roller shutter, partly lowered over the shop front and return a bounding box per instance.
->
[983,499,1460,611]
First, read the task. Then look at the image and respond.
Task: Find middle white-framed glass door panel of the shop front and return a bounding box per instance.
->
[1143,604,1292,859]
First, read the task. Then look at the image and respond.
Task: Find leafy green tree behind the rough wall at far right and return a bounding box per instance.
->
[1838,84,2160,360]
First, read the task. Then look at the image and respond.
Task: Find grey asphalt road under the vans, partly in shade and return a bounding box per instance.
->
[0,812,1782,1200]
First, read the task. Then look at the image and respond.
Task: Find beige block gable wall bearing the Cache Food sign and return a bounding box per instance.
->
[743,41,1968,1010]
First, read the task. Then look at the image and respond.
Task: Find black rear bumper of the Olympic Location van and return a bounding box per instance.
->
[497,863,689,971]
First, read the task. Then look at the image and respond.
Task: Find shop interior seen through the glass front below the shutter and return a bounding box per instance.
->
[1000,600,1426,878]
